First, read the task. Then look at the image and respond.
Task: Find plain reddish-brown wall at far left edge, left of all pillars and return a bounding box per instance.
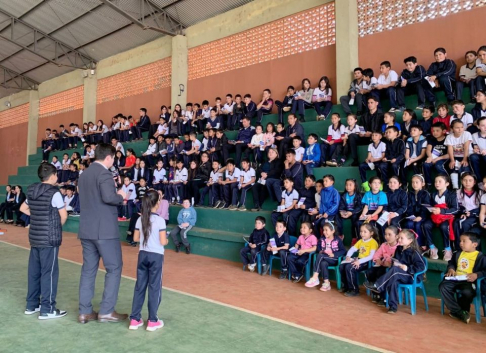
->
[0,123,28,183]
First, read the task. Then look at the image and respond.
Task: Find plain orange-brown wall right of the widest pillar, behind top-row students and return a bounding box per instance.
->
[359,6,486,76]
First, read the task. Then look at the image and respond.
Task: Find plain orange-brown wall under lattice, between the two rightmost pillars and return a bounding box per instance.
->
[187,45,336,104]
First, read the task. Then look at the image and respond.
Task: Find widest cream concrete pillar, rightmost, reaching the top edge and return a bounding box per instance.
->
[334,0,359,99]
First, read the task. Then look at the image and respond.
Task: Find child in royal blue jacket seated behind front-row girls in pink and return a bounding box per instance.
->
[314,174,340,237]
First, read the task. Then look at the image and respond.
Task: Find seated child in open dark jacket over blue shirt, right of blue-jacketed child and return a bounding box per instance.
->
[334,179,363,242]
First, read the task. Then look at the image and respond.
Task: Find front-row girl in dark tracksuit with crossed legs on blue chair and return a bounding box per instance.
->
[365,229,425,314]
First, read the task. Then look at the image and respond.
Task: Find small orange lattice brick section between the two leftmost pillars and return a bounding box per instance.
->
[39,86,84,118]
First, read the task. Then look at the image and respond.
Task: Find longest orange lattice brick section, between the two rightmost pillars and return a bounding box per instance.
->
[188,2,336,80]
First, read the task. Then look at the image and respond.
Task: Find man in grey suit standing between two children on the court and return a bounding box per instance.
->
[78,143,127,324]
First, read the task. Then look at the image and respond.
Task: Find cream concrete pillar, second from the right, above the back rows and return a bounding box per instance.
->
[170,35,188,109]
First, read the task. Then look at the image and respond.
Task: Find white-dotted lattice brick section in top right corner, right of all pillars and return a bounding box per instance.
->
[358,0,486,37]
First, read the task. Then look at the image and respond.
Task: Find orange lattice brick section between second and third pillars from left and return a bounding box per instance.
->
[96,57,172,104]
